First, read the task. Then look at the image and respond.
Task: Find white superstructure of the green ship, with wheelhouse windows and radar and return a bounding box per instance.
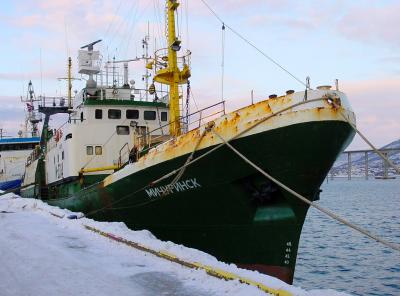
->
[24,42,170,192]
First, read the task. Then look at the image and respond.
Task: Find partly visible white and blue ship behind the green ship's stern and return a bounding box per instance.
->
[0,81,41,191]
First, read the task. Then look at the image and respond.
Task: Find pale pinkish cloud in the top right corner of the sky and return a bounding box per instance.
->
[337,2,400,47]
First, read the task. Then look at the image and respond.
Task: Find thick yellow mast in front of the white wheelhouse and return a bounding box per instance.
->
[154,0,190,136]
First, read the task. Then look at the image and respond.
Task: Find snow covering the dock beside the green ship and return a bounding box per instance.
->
[0,194,348,296]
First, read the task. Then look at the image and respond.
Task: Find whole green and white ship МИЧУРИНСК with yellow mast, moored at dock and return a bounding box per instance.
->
[21,0,355,283]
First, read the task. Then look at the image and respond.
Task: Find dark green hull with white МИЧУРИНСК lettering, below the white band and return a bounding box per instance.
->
[21,121,354,283]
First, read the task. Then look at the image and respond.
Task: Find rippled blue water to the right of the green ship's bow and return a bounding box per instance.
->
[294,179,400,296]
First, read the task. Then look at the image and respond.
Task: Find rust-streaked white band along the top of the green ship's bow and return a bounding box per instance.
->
[104,90,355,186]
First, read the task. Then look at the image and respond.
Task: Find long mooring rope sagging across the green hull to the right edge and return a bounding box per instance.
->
[212,129,400,251]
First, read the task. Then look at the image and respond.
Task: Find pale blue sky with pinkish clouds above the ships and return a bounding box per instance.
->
[0,0,400,149]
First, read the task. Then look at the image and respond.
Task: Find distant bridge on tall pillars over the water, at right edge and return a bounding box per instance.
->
[329,148,400,180]
